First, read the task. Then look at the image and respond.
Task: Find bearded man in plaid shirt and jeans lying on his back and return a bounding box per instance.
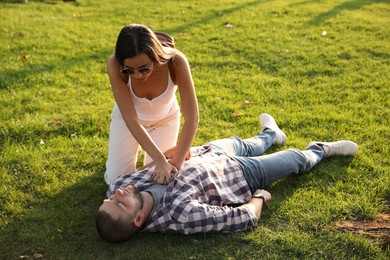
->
[96,114,358,243]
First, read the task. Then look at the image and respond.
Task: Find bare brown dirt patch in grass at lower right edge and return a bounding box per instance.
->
[335,212,390,250]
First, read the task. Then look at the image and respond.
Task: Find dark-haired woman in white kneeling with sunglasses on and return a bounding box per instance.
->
[105,24,199,184]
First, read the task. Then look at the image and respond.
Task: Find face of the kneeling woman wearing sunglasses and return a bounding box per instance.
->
[121,53,153,82]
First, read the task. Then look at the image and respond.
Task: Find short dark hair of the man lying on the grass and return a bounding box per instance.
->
[96,210,138,243]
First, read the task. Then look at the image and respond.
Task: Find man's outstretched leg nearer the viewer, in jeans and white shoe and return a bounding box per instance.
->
[234,141,357,192]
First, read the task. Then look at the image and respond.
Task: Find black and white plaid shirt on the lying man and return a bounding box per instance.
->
[107,148,257,234]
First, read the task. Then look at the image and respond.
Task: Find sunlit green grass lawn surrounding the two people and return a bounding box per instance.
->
[0,0,390,259]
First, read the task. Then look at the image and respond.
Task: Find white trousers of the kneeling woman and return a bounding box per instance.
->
[104,106,180,184]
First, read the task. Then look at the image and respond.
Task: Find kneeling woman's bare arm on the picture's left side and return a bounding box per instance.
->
[107,56,177,183]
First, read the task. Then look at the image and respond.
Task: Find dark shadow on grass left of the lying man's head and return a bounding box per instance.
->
[0,172,106,259]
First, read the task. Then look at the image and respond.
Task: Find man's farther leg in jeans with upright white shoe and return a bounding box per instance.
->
[208,114,286,157]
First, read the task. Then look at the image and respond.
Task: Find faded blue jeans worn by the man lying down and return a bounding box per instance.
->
[208,130,324,192]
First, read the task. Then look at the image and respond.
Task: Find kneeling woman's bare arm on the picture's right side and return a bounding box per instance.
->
[170,52,199,169]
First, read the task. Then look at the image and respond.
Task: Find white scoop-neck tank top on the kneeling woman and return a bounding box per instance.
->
[128,70,180,122]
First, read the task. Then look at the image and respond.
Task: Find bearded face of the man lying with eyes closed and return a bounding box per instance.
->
[99,185,142,218]
